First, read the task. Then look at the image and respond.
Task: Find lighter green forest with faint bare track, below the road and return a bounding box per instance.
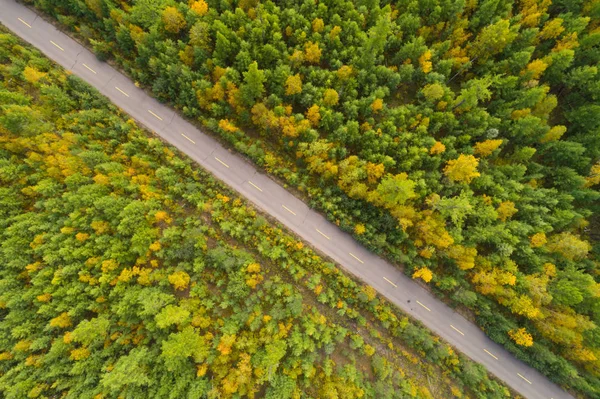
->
[0,27,511,399]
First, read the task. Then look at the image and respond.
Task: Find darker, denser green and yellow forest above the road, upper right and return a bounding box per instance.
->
[26,0,600,396]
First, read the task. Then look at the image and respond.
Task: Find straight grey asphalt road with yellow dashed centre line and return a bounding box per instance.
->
[0,0,572,399]
